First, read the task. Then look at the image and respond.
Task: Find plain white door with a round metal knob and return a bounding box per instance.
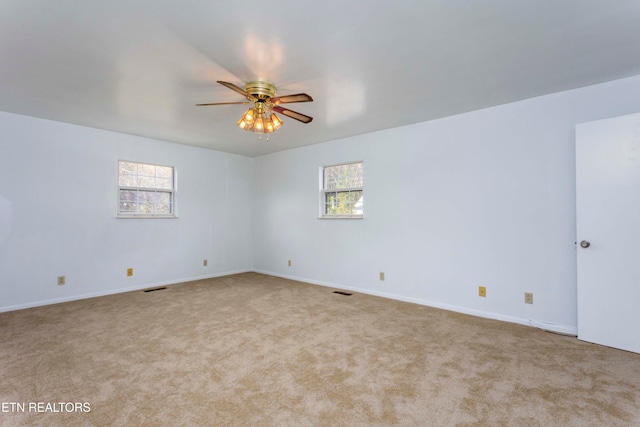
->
[576,114,640,353]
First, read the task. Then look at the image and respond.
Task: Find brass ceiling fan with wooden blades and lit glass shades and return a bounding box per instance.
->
[196,81,313,138]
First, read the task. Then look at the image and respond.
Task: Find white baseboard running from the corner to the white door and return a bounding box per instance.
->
[253,270,578,336]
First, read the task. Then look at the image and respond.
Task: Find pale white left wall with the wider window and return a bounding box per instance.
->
[0,113,252,311]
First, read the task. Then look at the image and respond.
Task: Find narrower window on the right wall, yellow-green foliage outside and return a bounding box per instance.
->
[321,162,364,218]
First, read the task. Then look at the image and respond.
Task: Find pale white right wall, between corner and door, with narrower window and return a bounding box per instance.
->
[253,76,640,333]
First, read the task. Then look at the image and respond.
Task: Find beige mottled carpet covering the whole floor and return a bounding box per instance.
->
[0,273,640,426]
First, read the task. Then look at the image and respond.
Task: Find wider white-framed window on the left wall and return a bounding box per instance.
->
[118,161,175,218]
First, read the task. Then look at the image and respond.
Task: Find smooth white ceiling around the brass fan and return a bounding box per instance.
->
[0,0,640,156]
